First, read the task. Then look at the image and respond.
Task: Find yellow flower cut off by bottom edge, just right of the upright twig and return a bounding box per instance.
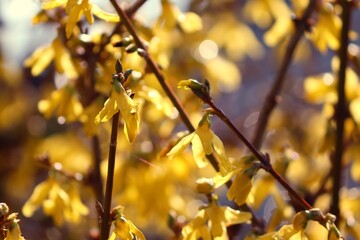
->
[109,207,145,240]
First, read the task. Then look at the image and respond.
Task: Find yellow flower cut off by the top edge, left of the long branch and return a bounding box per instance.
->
[42,0,120,38]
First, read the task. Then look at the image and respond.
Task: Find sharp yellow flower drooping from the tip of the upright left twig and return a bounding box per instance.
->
[95,79,140,142]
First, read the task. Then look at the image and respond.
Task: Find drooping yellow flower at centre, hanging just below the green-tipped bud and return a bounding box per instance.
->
[167,114,232,175]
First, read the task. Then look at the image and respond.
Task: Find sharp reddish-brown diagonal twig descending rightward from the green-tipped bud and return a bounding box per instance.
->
[206,98,312,210]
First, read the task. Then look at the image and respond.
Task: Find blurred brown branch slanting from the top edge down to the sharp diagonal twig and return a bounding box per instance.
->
[252,0,316,148]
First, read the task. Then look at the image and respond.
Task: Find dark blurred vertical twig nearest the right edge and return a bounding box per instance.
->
[330,0,351,223]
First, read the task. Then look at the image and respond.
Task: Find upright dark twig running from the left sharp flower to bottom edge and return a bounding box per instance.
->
[100,112,120,240]
